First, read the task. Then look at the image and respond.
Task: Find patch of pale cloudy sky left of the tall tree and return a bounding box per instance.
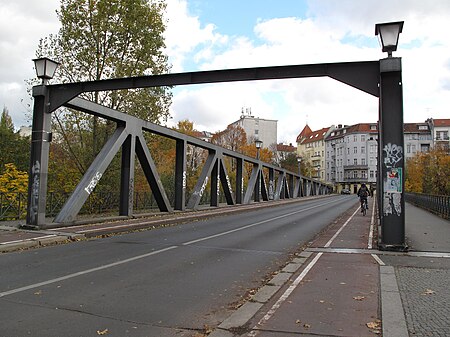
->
[0,0,59,127]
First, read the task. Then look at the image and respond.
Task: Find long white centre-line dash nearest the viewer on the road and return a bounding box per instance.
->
[0,246,178,298]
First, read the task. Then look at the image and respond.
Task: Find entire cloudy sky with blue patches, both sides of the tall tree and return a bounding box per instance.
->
[0,0,450,144]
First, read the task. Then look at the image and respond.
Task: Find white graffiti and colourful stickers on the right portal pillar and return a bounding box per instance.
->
[383,143,403,216]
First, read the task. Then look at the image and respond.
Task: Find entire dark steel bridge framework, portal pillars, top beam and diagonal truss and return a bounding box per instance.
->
[27,57,405,249]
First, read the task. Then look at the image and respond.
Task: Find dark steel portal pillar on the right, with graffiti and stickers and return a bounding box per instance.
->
[379,57,406,250]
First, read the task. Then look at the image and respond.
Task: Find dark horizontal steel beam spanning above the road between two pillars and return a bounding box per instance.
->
[47,61,380,112]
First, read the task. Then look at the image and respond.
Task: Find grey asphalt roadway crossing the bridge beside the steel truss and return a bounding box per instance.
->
[0,196,358,337]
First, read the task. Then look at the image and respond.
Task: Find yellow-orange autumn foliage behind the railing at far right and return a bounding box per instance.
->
[405,147,450,195]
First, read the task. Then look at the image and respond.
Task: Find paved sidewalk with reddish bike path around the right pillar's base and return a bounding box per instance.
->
[209,200,450,337]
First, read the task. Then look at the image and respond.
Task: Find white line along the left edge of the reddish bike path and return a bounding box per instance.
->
[247,207,361,337]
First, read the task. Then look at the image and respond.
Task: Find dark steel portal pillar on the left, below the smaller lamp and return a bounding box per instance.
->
[27,85,52,227]
